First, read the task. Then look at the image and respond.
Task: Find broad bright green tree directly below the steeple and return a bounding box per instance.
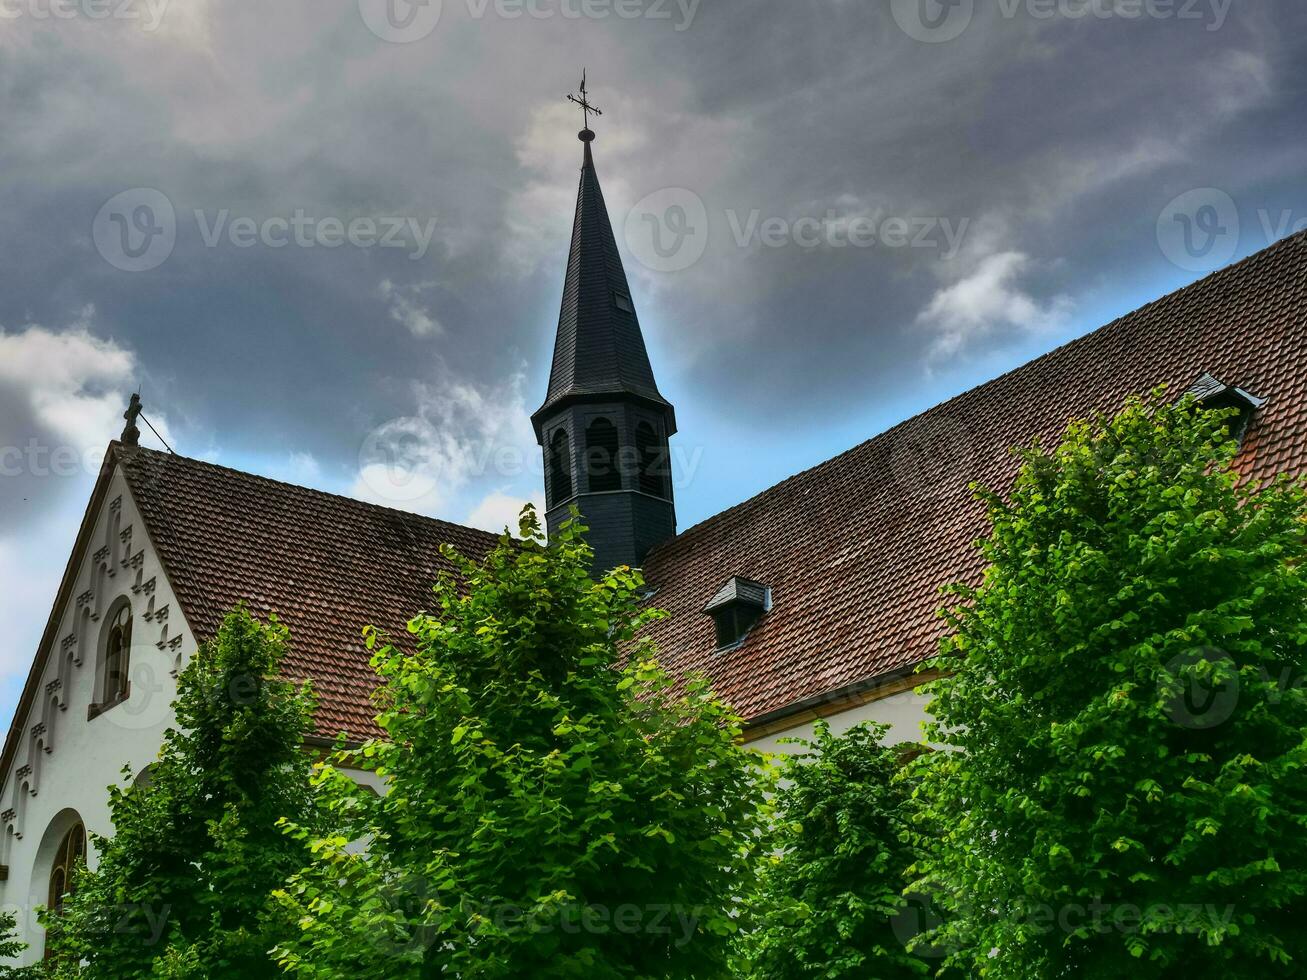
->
[270,508,766,980]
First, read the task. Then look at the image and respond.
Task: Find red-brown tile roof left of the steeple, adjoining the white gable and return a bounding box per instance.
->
[114,446,495,737]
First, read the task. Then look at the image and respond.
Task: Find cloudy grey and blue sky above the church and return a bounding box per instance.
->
[0,0,1307,716]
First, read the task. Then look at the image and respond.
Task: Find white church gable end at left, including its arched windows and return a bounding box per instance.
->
[0,447,195,953]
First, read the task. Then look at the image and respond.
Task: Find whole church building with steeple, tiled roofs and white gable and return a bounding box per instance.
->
[0,120,1307,960]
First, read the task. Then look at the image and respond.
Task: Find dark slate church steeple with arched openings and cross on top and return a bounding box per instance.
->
[531,90,676,571]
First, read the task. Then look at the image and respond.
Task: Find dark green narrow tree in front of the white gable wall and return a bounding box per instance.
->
[47,608,315,980]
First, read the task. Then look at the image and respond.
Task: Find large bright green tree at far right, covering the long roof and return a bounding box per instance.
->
[919,392,1307,980]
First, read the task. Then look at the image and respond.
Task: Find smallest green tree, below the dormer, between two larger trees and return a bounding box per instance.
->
[741,721,931,980]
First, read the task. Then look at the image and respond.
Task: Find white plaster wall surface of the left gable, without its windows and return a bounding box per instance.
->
[0,470,195,962]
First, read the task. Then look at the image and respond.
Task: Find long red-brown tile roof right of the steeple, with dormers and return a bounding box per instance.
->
[644,228,1307,721]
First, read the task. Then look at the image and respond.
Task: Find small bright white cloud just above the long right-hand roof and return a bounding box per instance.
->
[916,251,1070,357]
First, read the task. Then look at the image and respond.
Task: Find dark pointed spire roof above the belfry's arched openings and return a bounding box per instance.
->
[532,131,676,436]
